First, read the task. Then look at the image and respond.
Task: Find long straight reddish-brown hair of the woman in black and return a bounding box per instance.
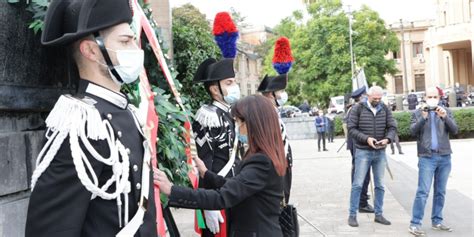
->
[231,95,288,176]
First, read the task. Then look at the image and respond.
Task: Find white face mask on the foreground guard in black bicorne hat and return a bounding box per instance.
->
[100,49,145,85]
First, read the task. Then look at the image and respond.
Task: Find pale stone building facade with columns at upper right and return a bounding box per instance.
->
[386,0,474,94]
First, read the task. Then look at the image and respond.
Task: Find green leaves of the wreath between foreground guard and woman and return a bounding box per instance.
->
[141,5,191,188]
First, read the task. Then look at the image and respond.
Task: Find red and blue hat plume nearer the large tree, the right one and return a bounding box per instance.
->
[272,37,294,74]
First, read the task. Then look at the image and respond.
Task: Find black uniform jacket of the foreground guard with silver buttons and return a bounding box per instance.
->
[25,80,157,237]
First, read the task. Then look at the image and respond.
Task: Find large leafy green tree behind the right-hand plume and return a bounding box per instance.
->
[265,0,399,107]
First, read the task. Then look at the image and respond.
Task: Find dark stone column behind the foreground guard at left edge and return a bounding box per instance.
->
[0,1,75,237]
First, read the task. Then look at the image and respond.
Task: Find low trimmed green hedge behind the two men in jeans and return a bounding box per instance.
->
[334,108,474,141]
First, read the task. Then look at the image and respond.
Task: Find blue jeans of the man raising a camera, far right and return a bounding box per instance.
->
[410,154,451,227]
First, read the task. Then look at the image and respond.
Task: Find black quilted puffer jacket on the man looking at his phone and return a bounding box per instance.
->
[347,102,397,150]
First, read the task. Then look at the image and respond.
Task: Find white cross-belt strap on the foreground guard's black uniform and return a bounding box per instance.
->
[116,140,151,237]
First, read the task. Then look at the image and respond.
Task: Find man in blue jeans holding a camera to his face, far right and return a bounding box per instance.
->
[408,87,458,236]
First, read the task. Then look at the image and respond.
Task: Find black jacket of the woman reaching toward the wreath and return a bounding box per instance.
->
[169,154,283,237]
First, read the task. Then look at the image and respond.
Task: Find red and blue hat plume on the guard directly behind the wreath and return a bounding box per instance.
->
[212,12,239,58]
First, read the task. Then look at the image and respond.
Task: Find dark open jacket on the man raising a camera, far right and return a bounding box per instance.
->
[410,108,458,157]
